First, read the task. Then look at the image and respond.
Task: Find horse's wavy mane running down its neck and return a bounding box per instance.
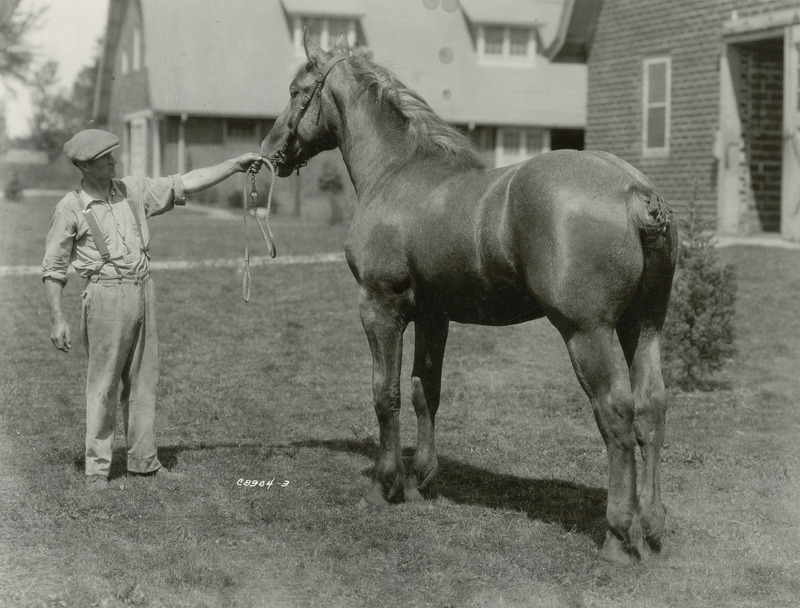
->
[302,48,486,169]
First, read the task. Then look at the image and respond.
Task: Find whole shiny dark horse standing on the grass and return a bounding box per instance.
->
[261,36,678,565]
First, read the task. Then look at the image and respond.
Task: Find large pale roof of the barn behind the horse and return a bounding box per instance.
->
[97,0,586,128]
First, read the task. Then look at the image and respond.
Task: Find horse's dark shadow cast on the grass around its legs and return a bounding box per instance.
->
[291,439,608,547]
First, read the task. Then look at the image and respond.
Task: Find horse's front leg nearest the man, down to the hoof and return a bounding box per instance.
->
[359,288,408,505]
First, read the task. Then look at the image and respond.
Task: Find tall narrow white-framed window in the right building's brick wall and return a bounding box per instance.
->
[642,57,672,156]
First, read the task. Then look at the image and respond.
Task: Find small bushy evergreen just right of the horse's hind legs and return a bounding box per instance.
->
[664,201,736,390]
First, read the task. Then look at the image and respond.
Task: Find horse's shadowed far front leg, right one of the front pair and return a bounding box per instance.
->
[405,315,449,500]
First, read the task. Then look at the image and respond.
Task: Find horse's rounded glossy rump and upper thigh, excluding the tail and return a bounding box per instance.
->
[507,151,644,331]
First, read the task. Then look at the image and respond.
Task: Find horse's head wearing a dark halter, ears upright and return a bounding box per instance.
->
[261,32,350,177]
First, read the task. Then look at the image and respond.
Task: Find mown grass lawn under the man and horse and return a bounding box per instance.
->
[0,200,800,608]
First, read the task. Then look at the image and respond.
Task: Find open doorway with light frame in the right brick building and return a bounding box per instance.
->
[716,17,800,239]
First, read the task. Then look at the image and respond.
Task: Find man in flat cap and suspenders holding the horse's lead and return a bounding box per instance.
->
[42,129,262,490]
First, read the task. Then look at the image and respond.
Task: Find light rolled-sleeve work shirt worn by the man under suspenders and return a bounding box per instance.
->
[42,175,186,283]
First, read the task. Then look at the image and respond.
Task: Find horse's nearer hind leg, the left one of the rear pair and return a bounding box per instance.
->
[565,327,643,565]
